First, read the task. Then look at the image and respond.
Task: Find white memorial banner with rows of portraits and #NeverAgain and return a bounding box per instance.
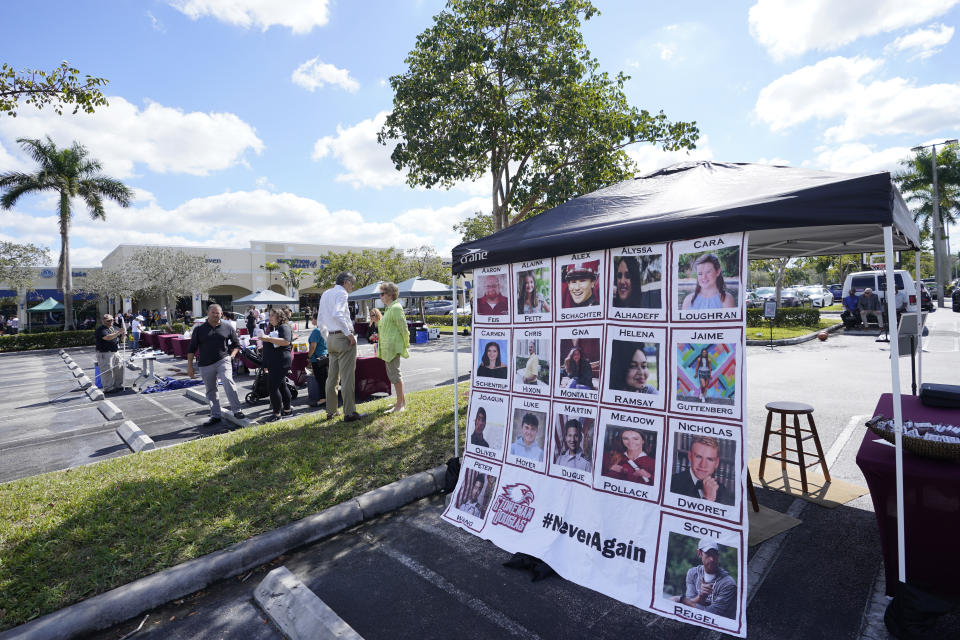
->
[443,234,748,637]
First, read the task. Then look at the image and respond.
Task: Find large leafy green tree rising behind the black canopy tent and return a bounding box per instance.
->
[378,0,699,230]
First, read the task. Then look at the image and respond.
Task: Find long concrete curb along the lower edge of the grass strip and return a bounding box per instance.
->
[0,465,447,640]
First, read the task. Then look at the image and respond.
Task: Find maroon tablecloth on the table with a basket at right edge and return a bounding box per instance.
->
[857,393,960,597]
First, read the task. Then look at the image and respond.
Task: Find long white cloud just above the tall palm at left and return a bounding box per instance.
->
[0,96,264,178]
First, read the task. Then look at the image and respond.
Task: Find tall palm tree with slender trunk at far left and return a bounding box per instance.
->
[0,136,133,330]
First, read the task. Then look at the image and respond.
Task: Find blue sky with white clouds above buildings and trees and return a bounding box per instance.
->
[0,0,960,265]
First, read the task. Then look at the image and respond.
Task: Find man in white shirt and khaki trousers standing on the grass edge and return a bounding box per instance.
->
[317,271,363,422]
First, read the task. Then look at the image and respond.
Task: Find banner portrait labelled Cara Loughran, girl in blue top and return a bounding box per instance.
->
[672,234,745,322]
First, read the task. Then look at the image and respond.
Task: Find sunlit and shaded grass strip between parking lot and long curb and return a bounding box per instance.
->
[0,383,467,630]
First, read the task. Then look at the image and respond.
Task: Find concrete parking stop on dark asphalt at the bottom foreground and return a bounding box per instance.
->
[253,567,363,640]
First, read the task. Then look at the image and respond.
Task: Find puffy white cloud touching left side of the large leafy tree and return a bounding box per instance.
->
[311,111,490,195]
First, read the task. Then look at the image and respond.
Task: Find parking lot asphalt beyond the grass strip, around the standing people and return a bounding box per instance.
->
[0,336,470,482]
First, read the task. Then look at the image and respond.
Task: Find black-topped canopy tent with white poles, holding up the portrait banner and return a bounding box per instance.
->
[452,162,922,582]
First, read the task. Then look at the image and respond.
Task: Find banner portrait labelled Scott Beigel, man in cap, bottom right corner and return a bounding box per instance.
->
[651,513,745,635]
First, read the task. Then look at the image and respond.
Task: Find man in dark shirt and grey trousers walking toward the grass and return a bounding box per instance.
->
[187,304,244,427]
